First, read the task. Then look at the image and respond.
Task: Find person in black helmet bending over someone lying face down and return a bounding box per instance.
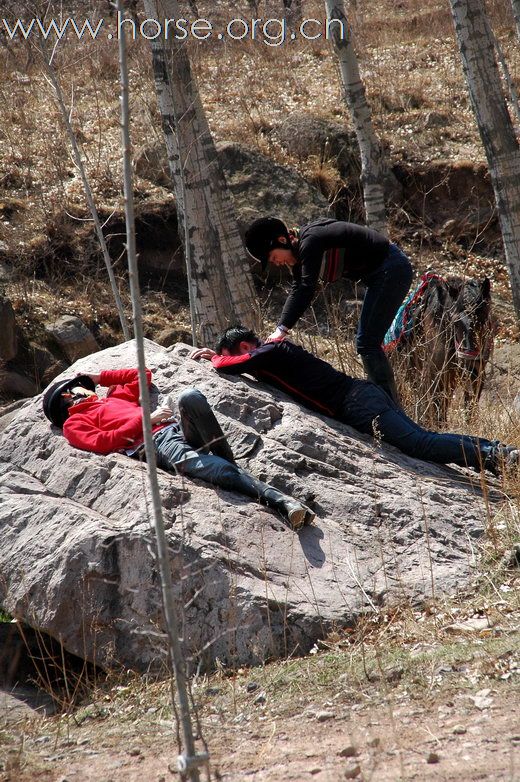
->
[245,217,413,403]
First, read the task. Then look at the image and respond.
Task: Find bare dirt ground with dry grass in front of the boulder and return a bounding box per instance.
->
[0,612,520,782]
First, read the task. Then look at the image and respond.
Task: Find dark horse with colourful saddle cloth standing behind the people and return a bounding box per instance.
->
[385,273,495,425]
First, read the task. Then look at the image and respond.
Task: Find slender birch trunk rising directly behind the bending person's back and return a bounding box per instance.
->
[325,0,392,234]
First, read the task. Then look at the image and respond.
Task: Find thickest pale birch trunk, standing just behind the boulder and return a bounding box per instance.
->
[144,0,259,344]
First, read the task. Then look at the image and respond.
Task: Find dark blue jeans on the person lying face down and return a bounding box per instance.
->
[336,380,497,469]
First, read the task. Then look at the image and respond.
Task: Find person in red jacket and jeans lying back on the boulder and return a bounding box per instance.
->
[43,369,314,529]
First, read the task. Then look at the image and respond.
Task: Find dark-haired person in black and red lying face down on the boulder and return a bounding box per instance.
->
[191,325,520,475]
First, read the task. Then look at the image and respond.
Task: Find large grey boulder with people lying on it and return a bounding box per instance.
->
[0,342,492,670]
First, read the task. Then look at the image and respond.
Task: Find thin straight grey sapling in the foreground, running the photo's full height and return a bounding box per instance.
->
[116,0,208,782]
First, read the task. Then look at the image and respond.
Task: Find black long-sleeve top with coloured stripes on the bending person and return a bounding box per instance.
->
[279,217,389,329]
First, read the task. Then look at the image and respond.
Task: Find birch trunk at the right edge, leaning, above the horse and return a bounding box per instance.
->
[450,0,520,317]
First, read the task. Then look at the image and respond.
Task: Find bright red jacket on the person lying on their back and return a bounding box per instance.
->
[63,369,169,454]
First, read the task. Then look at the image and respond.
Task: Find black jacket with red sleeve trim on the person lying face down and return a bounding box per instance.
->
[211,339,353,417]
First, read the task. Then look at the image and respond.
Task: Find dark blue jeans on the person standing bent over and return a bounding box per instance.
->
[356,244,413,356]
